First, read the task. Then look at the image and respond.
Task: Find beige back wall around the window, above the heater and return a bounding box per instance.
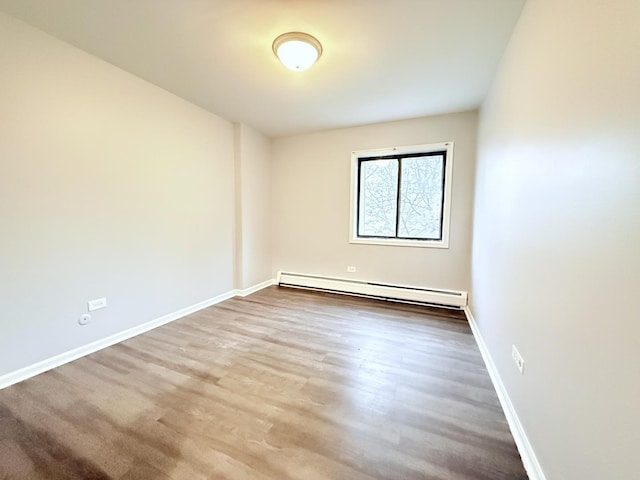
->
[271,112,477,290]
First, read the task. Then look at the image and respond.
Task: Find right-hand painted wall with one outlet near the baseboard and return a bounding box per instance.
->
[472,0,640,480]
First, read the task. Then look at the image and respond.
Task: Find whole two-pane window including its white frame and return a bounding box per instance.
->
[350,142,453,248]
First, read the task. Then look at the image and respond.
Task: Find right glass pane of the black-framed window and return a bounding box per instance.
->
[398,155,444,239]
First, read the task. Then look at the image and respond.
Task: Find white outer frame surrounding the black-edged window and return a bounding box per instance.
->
[349,142,453,248]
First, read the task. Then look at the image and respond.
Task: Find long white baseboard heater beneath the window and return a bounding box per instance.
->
[277,272,467,309]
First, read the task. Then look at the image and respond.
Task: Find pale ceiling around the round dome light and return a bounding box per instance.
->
[0,0,524,136]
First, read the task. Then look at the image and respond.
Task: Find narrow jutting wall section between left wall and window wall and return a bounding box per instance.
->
[234,123,273,290]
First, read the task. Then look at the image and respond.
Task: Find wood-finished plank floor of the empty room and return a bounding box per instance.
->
[0,287,527,480]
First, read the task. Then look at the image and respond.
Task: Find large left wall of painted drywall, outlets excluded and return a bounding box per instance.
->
[0,15,234,375]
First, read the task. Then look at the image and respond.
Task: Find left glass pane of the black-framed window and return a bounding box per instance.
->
[358,159,398,237]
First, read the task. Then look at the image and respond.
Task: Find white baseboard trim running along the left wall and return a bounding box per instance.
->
[0,279,275,390]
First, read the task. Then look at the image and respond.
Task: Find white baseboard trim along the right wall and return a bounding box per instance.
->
[464,306,547,480]
